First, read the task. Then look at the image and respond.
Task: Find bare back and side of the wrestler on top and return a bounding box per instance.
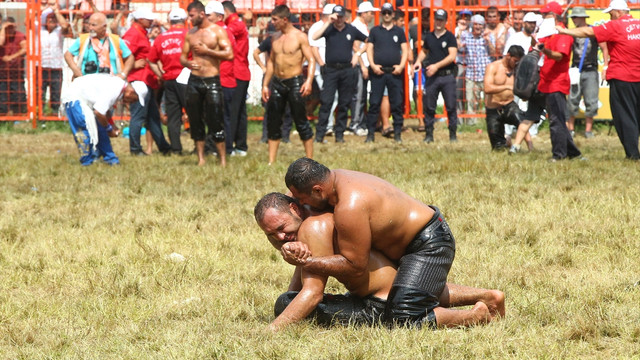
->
[334,169,435,261]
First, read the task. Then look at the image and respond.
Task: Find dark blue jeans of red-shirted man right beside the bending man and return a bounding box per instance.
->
[129,86,171,154]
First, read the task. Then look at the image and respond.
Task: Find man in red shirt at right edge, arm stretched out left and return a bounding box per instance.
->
[558,0,640,160]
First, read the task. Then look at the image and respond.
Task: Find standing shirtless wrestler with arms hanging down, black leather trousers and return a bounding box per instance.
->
[262,5,315,165]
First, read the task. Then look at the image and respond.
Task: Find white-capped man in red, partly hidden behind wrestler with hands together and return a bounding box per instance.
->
[204,1,237,155]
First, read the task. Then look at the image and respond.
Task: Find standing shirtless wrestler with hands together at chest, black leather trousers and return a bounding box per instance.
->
[180,1,233,167]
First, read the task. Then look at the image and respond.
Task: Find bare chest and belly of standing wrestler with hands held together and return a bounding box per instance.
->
[185,24,220,77]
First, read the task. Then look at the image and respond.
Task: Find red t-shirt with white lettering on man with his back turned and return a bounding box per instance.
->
[149,25,187,80]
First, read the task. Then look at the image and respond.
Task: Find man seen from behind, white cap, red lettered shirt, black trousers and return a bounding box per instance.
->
[149,8,187,155]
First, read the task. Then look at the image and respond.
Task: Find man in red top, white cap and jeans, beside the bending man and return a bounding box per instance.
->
[122,7,171,155]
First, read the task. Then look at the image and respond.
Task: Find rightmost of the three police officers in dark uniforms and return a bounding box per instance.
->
[414,9,458,143]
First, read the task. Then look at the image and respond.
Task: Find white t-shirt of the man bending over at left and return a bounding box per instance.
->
[62,74,127,115]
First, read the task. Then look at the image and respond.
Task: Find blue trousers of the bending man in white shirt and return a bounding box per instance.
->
[65,100,120,166]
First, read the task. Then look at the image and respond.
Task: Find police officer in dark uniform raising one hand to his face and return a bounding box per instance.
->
[312,5,367,143]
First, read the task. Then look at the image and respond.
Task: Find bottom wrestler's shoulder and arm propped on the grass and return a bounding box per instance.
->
[269,215,333,331]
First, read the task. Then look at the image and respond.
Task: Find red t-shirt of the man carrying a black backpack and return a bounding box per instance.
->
[538,25,573,95]
